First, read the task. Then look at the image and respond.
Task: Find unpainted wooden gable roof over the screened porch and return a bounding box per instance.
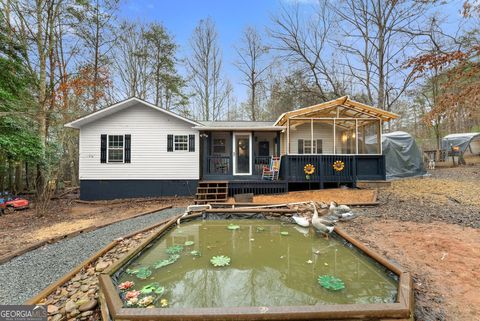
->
[275,96,399,126]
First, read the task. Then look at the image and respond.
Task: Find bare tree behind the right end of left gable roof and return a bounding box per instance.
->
[187,18,229,120]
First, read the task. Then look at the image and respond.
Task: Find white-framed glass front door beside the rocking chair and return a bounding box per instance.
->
[233,133,252,175]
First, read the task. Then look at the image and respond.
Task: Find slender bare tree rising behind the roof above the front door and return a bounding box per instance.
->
[235,27,273,120]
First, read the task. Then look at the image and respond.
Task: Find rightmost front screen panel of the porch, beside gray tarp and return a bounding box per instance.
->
[358,119,382,154]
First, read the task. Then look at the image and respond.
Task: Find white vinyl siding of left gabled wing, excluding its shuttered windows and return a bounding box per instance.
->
[79,103,200,180]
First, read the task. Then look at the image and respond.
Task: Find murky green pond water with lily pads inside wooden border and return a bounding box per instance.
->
[116,219,398,308]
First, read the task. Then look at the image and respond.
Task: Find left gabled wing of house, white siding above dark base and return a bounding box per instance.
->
[65,98,200,200]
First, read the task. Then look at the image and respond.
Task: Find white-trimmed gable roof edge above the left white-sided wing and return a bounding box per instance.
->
[64,97,201,128]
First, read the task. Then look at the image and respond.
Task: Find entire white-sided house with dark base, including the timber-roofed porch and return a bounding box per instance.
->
[65,96,398,200]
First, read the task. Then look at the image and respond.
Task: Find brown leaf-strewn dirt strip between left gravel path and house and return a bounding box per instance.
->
[0,195,193,257]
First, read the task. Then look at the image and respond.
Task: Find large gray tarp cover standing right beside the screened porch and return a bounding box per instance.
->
[382,131,426,179]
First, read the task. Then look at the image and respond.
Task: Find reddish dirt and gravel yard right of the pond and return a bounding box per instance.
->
[341,165,480,321]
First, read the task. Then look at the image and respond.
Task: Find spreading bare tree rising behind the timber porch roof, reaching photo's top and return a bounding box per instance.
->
[329,0,426,114]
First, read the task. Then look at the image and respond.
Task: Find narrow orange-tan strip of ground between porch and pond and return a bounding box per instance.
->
[249,188,375,204]
